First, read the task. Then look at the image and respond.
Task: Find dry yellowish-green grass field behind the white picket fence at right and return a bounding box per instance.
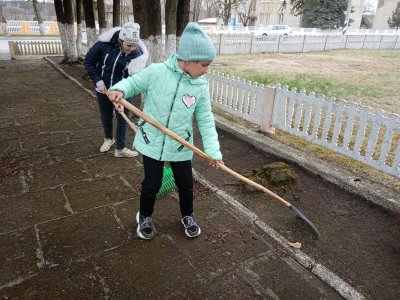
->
[211,50,400,114]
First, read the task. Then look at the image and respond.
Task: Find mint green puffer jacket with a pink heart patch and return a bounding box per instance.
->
[110,55,222,161]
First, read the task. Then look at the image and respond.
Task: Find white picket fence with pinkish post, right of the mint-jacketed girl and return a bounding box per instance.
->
[207,72,400,177]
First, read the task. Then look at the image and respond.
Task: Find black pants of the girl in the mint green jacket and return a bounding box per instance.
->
[140,155,193,217]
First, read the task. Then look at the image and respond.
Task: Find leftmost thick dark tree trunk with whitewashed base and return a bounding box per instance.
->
[54,0,78,63]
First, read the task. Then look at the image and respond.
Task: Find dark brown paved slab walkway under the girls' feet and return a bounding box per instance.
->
[0,60,350,299]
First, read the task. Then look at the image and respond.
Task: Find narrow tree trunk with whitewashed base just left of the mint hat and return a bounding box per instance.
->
[165,0,178,57]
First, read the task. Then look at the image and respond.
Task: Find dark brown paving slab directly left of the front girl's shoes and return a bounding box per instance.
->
[37,207,128,269]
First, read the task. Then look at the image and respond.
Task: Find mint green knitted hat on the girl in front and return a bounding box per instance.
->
[178,22,215,61]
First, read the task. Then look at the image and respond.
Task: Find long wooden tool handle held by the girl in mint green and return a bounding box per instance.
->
[120,99,291,207]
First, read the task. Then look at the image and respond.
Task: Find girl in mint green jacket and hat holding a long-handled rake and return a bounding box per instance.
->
[108,23,223,239]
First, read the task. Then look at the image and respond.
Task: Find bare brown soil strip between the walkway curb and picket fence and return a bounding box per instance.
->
[52,54,400,299]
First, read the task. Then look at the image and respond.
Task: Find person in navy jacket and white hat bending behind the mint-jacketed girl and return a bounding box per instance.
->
[84,22,148,157]
